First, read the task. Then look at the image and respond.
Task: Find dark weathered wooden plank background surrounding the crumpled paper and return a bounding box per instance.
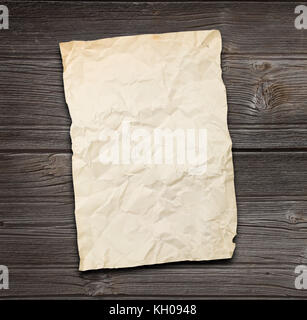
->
[0,1,307,298]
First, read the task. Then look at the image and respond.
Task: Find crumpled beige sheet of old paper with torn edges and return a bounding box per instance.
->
[60,30,237,270]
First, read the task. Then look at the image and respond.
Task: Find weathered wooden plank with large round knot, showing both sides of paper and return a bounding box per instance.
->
[0,53,307,129]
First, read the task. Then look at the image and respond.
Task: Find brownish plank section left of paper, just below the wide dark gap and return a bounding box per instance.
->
[0,154,73,198]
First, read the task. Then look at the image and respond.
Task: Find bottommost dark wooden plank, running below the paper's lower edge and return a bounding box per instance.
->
[0,264,306,299]
